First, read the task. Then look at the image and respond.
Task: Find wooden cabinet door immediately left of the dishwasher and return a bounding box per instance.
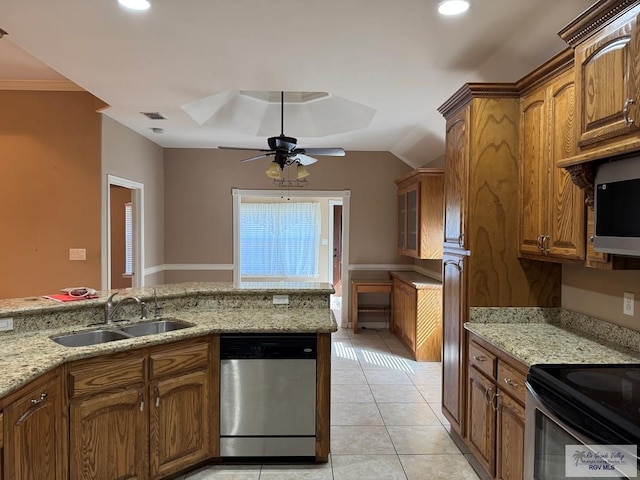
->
[149,370,212,479]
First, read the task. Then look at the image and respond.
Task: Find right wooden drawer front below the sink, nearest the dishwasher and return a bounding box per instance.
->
[149,339,209,378]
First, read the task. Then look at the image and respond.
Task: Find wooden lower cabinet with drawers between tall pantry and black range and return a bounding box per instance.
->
[465,334,527,480]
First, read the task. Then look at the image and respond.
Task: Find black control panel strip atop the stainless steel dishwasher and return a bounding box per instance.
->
[220,333,317,360]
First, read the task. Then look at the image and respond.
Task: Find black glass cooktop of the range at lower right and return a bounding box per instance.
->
[527,364,640,445]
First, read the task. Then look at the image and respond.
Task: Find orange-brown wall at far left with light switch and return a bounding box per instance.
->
[0,91,101,298]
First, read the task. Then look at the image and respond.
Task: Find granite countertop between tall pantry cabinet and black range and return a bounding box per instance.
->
[464,322,640,366]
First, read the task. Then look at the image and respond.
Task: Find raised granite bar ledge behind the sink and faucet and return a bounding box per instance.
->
[0,282,334,317]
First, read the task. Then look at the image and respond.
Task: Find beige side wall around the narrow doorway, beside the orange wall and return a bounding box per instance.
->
[102,116,164,285]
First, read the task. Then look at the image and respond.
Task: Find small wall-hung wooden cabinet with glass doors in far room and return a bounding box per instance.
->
[395,168,444,259]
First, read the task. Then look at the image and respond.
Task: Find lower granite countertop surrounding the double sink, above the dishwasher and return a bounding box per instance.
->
[0,306,338,397]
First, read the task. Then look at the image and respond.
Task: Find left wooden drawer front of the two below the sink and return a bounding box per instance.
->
[69,353,144,397]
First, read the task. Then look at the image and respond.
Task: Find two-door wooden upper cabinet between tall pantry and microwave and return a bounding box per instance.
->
[519,51,586,263]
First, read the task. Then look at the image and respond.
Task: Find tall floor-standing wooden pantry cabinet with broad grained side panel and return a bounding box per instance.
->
[439,84,561,437]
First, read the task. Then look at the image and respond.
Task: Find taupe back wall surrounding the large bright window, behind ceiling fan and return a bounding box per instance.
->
[165,149,411,283]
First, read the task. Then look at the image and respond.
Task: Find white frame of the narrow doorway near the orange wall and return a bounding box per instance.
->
[102,175,144,290]
